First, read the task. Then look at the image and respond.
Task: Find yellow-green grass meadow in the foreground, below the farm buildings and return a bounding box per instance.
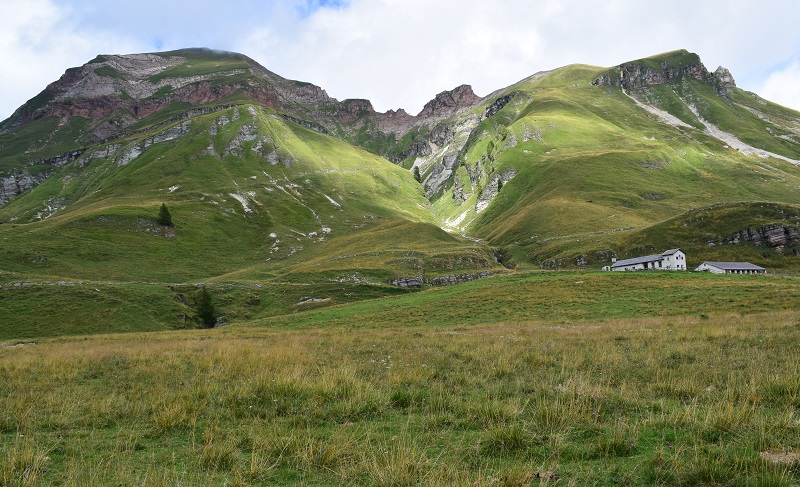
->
[0,273,800,486]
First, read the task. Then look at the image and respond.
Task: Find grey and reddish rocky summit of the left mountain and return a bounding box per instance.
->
[0,49,322,140]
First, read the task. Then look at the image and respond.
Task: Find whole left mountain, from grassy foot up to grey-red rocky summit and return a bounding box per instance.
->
[0,49,501,285]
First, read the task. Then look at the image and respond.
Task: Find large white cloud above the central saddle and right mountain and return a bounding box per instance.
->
[238,0,800,113]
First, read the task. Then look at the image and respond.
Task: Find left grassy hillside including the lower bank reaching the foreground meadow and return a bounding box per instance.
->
[0,107,497,337]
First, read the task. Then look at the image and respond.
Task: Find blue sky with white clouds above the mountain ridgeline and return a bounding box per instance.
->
[0,0,800,120]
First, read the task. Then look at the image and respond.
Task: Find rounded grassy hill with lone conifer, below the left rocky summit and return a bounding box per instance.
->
[0,106,493,284]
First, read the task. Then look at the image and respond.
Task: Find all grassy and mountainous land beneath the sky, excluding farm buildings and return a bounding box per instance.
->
[0,49,800,487]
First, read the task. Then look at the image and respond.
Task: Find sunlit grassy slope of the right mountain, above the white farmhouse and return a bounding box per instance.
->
[436,53,800,266]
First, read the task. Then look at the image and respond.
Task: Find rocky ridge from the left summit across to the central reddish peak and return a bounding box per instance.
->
[0,49,481,171]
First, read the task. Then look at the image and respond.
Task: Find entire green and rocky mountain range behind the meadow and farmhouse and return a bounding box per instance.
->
[0,49,800,336]
